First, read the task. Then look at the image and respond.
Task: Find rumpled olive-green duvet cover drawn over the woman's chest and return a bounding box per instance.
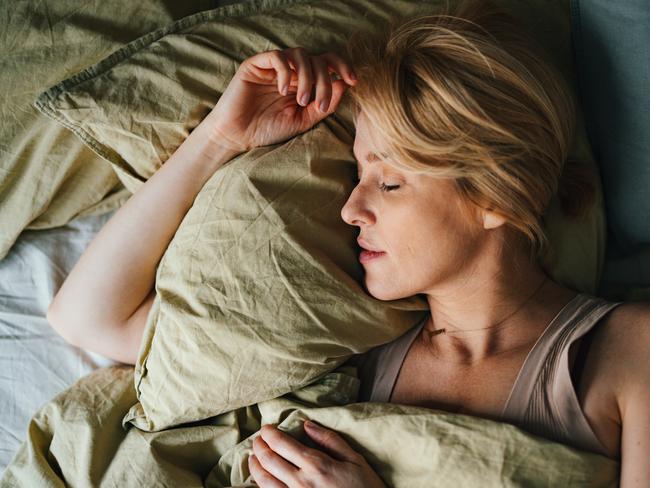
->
[0,365,618,488]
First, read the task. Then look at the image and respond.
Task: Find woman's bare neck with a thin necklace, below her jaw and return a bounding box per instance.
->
[421,243,576,365]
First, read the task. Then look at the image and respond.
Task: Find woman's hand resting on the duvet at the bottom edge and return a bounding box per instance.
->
[248,421,386,488]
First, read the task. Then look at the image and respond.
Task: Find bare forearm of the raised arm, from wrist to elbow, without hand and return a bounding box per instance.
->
[48,120,237,338]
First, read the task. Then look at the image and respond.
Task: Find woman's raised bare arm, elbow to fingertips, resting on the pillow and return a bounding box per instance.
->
[47,48,356,364]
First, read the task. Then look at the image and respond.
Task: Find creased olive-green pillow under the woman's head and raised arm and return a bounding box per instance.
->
[36,0,603,430]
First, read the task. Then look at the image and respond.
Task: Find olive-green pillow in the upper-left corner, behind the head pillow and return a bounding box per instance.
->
[0,0,218,260]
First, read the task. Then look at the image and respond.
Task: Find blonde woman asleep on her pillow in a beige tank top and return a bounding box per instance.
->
[48,2,650,488]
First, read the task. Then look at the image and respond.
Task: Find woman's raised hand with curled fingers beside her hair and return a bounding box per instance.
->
[201,47,356,153]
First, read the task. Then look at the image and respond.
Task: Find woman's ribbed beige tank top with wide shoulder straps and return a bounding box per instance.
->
[352,293,621,455]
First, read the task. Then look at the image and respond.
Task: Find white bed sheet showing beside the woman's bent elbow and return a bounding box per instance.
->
[0,211,118,472]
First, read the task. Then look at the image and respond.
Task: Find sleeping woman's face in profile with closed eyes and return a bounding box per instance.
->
[341,113,485,300]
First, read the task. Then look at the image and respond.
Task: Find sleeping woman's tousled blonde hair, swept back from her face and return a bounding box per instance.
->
[348,0,594,257]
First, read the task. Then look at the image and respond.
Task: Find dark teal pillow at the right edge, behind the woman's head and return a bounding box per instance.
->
[571,0,650,300]
